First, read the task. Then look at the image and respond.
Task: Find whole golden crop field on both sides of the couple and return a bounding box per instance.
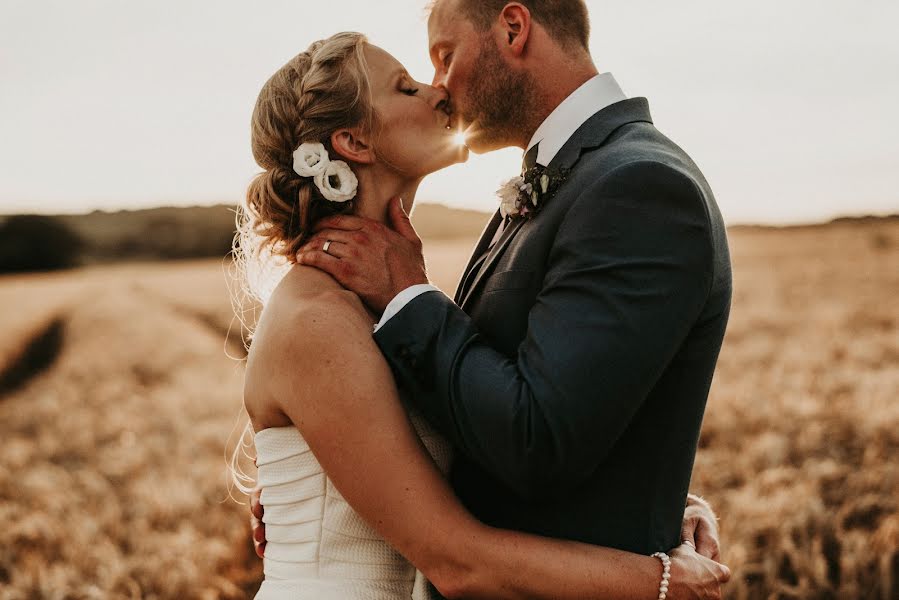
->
[0,217,899,600]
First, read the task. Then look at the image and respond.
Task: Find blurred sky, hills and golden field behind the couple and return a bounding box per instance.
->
[0,0,899,600]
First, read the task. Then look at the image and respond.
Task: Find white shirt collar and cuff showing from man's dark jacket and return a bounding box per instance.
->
[375,73,627,331]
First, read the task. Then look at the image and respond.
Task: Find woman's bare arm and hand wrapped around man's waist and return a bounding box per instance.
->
[257,293,726,600]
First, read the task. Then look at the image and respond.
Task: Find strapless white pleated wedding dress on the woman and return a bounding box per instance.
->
[255,414,452,600]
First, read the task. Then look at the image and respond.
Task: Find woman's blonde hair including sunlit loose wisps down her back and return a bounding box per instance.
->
[230,32,375,493]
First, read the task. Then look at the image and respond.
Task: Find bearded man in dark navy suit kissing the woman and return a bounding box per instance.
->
[255,0,731,557]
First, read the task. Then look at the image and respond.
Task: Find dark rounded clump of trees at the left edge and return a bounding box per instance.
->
[0,215,84,273]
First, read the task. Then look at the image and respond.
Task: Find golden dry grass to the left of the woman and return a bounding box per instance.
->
[0,262,260,599]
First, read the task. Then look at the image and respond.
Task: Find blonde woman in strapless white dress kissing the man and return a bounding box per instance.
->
[239,33,729,600]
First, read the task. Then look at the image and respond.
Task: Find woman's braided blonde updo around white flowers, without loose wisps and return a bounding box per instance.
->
[239,32,374,263]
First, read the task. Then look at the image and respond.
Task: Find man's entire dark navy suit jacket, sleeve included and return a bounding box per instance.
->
[375,98,731,554]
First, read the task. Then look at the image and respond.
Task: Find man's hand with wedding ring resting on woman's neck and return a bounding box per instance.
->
[297,198,428,315]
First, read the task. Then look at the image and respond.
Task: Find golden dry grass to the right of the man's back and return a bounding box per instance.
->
[693,220,899,599]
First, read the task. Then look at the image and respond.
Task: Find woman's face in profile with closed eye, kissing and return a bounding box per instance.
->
[365,44,468,179]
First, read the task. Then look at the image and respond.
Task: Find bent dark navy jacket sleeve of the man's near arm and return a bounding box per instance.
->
[375,162,713,498]
